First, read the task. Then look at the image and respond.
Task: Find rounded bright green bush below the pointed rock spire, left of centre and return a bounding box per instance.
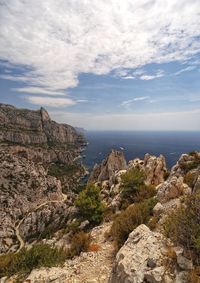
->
[75,184,104,224]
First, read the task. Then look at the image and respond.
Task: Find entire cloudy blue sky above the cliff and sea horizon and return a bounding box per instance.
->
[0,0,200,131]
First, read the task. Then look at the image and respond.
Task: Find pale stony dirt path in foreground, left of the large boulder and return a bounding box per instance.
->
[28,223,114,283]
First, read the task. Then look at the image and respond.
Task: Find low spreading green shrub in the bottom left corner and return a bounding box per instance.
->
[0,244,67,277]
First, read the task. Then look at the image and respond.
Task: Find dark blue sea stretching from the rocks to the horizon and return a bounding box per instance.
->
[84,131,200,169]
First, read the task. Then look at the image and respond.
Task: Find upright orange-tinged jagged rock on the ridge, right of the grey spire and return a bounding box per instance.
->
[129,153,167,186]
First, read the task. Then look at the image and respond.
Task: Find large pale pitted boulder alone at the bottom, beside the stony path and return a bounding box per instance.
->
[109,224,174,283]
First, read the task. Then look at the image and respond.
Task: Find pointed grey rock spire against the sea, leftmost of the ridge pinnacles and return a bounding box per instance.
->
[89,150,127,185]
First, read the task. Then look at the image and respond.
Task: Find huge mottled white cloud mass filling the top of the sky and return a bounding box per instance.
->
[0,0,200,94]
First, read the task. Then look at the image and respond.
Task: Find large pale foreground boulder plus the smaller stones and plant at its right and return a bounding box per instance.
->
[109,224,193,283]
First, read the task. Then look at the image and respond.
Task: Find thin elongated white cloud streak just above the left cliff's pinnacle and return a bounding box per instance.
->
[25,96,76,107]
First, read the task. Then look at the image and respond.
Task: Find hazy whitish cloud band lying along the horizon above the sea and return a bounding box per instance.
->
[50,109,200,131]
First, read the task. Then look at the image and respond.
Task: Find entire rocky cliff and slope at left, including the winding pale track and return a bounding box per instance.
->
[0,104,85,253]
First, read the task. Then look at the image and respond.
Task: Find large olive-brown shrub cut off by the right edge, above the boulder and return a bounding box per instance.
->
[164,194,200,264]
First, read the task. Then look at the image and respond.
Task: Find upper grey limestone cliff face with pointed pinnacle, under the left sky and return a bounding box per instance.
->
[0,104,83,145]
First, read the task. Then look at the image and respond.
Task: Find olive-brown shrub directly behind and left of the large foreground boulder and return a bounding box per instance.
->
[110,198,156,248]
